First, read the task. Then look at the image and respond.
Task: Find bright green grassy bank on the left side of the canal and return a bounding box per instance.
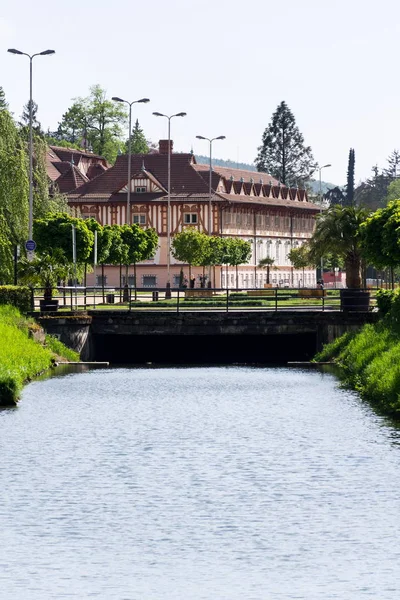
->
[0,306,79,406]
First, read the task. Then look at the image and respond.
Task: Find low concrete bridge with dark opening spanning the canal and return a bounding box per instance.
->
[38,310,378,364]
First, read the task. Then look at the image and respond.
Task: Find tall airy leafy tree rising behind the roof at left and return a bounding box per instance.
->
[58,85,126,162]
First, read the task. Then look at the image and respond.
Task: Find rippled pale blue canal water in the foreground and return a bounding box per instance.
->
[0,366,400,600]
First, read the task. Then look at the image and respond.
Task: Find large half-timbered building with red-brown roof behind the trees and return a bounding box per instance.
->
[62,140,320,288]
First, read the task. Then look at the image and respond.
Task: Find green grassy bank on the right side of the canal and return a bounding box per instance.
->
[314,290,400,419]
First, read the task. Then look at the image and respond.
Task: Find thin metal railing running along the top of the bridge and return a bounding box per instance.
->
[31,286,376,313]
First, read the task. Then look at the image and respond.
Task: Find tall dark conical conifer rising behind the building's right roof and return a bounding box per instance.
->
[255,102,315,185]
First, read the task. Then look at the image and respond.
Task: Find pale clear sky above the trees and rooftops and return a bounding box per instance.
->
[0,0,400,184]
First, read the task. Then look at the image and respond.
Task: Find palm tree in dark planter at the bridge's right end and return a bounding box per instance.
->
[310,205,368,289]
